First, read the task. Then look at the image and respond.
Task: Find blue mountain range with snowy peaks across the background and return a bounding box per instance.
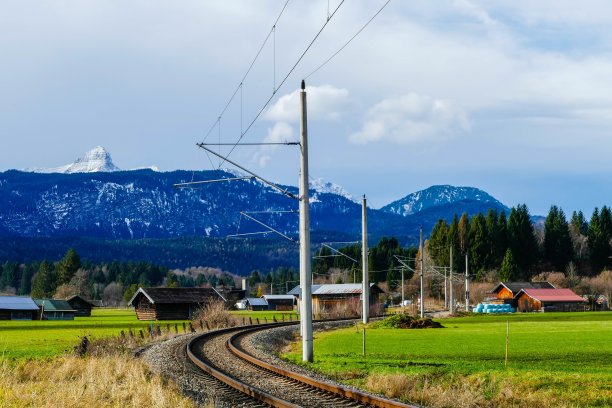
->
[0,147,508,272]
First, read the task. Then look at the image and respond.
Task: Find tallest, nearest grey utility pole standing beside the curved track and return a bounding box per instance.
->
[300,80,313,362]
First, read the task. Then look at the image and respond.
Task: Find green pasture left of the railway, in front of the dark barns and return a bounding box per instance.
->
[0,309,188,359]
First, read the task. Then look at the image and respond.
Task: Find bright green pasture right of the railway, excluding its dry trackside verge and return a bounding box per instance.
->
[284,312,612,405]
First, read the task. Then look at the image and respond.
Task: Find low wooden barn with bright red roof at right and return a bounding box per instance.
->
[515,288,588,312]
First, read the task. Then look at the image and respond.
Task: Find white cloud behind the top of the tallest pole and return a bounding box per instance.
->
[264,85,349,122]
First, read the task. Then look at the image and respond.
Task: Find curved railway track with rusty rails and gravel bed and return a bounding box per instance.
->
[187,323,413,408]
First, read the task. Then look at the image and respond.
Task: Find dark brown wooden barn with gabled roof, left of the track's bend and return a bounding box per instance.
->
[128,288,226,320]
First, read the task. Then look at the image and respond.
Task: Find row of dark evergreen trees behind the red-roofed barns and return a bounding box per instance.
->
[427,204,612,281]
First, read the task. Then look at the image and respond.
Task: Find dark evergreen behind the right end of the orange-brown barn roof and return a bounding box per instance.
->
[544,205,574,271]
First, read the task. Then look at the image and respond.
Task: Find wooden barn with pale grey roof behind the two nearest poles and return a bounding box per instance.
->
[287,283,384,316]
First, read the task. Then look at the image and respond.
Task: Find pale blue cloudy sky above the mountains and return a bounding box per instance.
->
[0,0,612,216]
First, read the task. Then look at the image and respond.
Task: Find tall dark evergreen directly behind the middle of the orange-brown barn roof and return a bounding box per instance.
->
[508,204,538,280]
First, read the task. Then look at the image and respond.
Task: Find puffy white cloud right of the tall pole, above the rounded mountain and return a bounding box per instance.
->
[350,93,470,144]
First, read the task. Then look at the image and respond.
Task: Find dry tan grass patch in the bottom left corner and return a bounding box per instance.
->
[0,355,195,407]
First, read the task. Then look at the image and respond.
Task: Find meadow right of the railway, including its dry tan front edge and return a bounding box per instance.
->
[284,312,612,407]
